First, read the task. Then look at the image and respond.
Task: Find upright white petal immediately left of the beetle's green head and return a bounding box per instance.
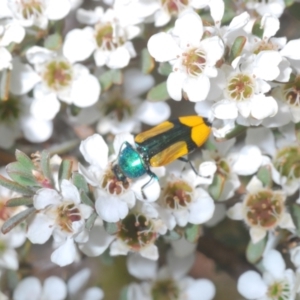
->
[79,134,108,170]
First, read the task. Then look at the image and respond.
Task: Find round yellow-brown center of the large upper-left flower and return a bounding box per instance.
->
[42,59,73,91]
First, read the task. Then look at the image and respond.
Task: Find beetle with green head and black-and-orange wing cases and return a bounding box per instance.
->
[112,116,211,195]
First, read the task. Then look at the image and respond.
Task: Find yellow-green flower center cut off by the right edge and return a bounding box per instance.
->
[273,146,300,181]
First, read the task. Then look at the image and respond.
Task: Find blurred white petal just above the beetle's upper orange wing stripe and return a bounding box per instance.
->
[136,101,171,126]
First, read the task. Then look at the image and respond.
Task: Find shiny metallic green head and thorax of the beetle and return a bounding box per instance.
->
[113,142,148,181]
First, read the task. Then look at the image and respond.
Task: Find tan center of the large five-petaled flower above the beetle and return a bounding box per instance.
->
[182,48,206,76]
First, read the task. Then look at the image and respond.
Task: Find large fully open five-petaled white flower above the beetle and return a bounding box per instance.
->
[148,11,224,102]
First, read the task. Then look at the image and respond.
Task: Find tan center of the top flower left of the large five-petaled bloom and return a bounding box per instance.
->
[95,23,125,51]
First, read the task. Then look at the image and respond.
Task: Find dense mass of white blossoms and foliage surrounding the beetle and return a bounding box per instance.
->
[0,0,300,300]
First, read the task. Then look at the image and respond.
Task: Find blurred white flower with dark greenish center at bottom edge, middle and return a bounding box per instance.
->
[127,252,216,300]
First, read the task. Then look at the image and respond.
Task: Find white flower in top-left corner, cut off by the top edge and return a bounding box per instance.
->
[4,0,71,29]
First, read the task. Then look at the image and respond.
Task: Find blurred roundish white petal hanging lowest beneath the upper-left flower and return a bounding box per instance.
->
[21,116,53,143]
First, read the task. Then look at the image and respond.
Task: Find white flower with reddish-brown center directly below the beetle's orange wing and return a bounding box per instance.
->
[158,170,215,230]
